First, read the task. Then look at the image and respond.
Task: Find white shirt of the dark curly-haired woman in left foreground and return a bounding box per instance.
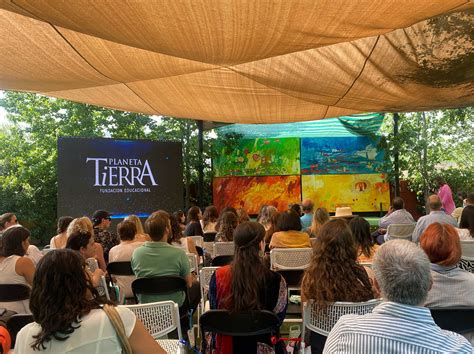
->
[15,307,136,354]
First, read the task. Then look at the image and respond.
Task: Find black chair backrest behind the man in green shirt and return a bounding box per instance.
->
[132,275,189,310]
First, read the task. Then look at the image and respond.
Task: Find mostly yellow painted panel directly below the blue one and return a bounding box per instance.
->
[301,174,390,212]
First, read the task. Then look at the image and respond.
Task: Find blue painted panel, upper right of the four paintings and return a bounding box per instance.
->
[301,136,384,175]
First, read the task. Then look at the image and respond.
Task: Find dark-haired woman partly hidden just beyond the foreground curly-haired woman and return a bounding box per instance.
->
[66,229,105,287]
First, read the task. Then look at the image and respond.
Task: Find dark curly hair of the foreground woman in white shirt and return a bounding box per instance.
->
[30,249,111,350]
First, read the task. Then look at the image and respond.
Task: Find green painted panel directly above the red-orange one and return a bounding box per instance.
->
[213,138,300,177]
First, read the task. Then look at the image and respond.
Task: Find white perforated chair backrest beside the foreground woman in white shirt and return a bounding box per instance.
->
[123,301,183,340]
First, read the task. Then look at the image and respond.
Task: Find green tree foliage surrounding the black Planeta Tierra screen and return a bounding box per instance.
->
[0,92,210,243]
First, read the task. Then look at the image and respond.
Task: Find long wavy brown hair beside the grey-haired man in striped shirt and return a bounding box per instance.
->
[301,220,373,308]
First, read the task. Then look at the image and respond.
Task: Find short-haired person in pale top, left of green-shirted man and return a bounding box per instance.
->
[109,221,143,300]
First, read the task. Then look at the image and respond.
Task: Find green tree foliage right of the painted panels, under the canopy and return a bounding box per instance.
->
[382,107,474,201]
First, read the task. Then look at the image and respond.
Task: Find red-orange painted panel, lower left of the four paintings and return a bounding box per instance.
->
[213,176,301,214]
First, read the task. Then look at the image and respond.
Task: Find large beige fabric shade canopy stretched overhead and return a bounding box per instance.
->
[0,0,474,123]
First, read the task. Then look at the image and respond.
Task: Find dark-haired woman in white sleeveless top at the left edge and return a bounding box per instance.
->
[0,226,35,313]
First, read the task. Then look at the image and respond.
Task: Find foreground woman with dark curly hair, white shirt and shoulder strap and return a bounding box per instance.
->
[15,249,166,354]
